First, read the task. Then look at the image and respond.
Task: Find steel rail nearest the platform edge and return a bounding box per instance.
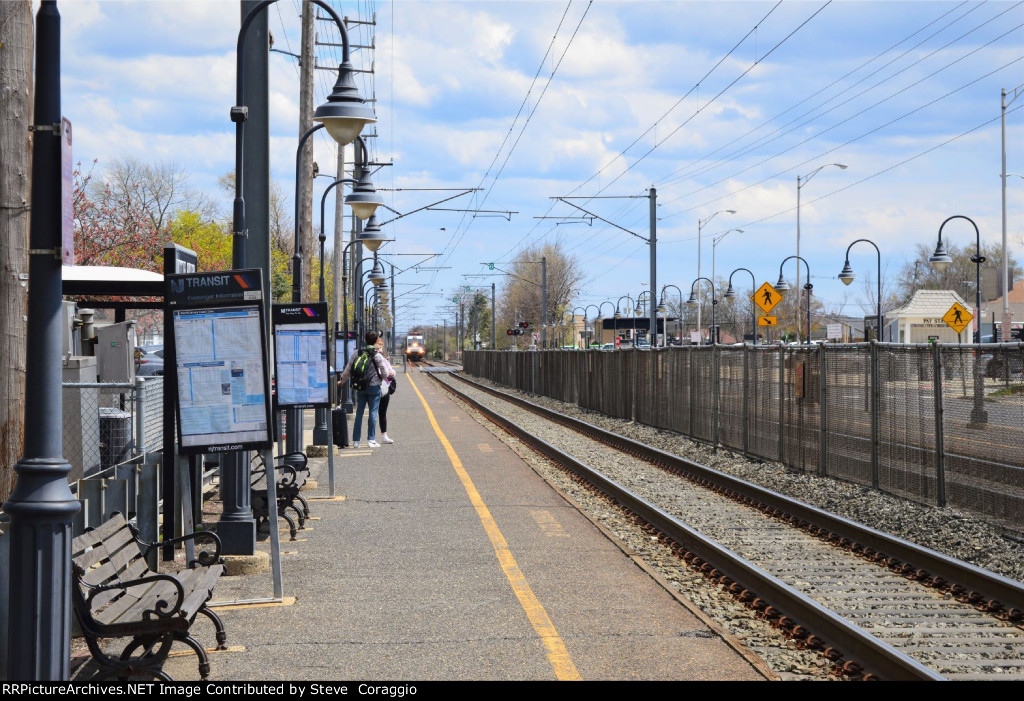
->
[431,376,944,681]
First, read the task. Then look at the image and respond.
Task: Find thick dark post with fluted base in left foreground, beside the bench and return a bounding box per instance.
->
[0,0,80,682]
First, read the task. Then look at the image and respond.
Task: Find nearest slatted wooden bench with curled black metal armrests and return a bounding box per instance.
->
[72,514,227,682]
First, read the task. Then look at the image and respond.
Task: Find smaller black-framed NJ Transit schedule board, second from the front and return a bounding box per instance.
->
[272,302,331,408]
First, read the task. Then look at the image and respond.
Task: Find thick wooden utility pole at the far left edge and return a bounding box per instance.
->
[0,0,33,503]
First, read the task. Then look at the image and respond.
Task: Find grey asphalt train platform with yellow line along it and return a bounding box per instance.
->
[79,368,771,682]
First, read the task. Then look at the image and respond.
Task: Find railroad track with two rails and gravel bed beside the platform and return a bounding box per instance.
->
[431,373,1024,681]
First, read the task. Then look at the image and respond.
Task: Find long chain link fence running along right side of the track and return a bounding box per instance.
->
[463,342,1024,529]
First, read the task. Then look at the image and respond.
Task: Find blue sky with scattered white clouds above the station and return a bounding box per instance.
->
[51,0,1024,335]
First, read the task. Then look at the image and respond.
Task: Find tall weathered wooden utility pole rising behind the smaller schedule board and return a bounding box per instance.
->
[295,1,319,301]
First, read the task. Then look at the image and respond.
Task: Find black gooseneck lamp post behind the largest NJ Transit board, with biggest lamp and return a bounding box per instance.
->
[224,0,377,555]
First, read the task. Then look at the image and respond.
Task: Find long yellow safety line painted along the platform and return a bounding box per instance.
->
[409,375,583,682]
